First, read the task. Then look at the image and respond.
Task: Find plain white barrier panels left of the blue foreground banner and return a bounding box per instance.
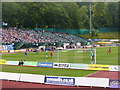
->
[0,72,45,83]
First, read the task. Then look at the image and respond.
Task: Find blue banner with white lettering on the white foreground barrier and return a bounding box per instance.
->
[45,76,75,85]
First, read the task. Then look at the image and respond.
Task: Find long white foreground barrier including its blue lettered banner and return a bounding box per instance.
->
[0,72,113,88]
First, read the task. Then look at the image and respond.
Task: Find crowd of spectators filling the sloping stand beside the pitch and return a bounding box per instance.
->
[0,28,84,44]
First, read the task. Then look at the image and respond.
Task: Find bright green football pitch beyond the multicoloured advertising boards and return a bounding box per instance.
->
[2,47,120,65]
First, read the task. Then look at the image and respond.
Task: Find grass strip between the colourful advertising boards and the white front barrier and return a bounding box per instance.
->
[2,65,96,77]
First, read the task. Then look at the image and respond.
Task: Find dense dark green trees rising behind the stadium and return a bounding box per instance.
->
[2,2,120,29]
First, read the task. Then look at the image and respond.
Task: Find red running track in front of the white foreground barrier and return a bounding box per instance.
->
[2,81,117,90]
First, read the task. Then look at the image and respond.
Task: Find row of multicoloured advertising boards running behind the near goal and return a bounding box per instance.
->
[0,60,120,71]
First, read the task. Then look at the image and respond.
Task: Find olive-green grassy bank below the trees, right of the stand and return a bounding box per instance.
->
[78,32,120,39]
